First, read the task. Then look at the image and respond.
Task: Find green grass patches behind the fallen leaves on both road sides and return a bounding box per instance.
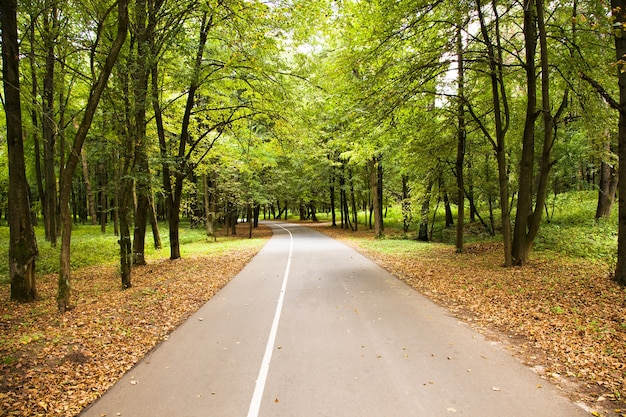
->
[0,191,617,284]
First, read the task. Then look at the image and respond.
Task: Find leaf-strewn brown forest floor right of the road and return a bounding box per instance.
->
[318,223,626,417]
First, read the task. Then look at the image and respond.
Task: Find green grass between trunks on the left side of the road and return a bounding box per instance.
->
[0,222,264,284]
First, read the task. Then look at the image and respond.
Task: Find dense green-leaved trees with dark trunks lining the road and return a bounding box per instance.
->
[0,0,626,311]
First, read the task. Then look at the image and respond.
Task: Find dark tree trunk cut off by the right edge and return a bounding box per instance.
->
[611,0,626,285]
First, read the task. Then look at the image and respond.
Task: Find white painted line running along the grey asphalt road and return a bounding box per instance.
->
[248,225,293,417]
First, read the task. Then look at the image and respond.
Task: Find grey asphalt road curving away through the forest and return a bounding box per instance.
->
[82,224,589,417]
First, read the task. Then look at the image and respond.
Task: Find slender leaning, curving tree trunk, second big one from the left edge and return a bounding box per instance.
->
[57,0,128,312]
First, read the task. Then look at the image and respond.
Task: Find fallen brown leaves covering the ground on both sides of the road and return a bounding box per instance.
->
[0,224,626,417]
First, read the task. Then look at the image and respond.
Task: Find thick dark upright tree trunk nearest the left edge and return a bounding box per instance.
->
[0,0,38,302]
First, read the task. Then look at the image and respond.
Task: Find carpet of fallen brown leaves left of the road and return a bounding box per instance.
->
[0,225,271,417]
